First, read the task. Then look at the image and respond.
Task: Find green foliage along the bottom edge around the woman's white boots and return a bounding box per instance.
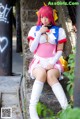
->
[37,102,80,119]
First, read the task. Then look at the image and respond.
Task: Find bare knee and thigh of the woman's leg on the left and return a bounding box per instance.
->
[32,67,47,82]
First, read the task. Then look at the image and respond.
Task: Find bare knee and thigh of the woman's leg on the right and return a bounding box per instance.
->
[47,69,60,86]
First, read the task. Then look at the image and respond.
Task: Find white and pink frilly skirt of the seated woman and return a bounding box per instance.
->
[28,55,64,79]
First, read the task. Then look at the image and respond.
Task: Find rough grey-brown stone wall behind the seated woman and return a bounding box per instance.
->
[21,0,71,119]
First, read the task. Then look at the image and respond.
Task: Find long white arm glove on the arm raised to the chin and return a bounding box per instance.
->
[30,31,41,52]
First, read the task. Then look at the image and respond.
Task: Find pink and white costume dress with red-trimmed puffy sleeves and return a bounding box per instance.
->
[28,26,67,79]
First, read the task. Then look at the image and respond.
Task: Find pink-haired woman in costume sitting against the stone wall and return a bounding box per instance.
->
[28,6,68,119]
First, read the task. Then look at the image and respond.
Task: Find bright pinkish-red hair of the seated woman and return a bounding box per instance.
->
[37,6,55,25]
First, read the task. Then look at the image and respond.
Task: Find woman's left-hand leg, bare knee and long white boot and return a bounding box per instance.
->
[29,68,46,119]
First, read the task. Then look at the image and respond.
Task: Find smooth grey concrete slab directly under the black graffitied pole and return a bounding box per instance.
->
[0,75,21,93]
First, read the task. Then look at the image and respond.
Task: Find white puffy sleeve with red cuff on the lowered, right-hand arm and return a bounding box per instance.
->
[58,28,67,43]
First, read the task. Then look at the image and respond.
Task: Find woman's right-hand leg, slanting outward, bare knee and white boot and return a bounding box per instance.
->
[47,69,68,109]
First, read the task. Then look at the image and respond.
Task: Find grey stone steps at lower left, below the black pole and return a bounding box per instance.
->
[0,75,23,119]
